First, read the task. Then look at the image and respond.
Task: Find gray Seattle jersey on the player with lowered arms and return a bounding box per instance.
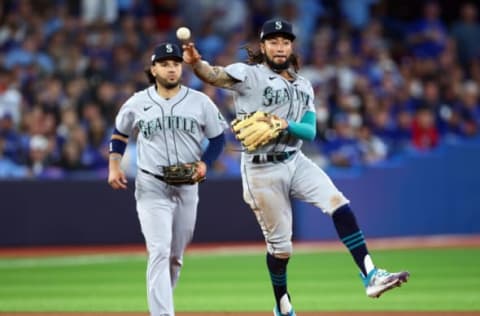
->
[115,86,228,174]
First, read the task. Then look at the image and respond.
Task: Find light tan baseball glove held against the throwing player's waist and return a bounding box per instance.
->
[231,111,285,152]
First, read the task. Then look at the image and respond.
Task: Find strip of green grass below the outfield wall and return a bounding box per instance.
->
[0,249,480,311]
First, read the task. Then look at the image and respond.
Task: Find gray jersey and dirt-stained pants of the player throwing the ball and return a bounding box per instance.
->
[225,63,349,255]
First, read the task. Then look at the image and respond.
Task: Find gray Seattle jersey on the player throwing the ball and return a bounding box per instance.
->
[225,63,315,153]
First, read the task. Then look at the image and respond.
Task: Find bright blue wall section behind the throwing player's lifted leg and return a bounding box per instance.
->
[295,141,480,240]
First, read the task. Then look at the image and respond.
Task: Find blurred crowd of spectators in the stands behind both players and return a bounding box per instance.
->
[0,0,480,179]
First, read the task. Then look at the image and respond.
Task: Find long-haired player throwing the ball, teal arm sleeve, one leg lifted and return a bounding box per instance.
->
[183,19,409,316]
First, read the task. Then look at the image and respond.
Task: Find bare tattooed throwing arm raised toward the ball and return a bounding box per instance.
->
[183,43,237,88]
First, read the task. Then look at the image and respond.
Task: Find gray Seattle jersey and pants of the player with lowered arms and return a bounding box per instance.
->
[115,86,228,316]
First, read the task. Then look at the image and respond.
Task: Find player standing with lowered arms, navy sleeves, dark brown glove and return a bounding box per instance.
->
[108,43,228,316]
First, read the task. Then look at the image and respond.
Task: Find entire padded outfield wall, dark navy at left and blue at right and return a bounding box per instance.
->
[0,141,480,246]
